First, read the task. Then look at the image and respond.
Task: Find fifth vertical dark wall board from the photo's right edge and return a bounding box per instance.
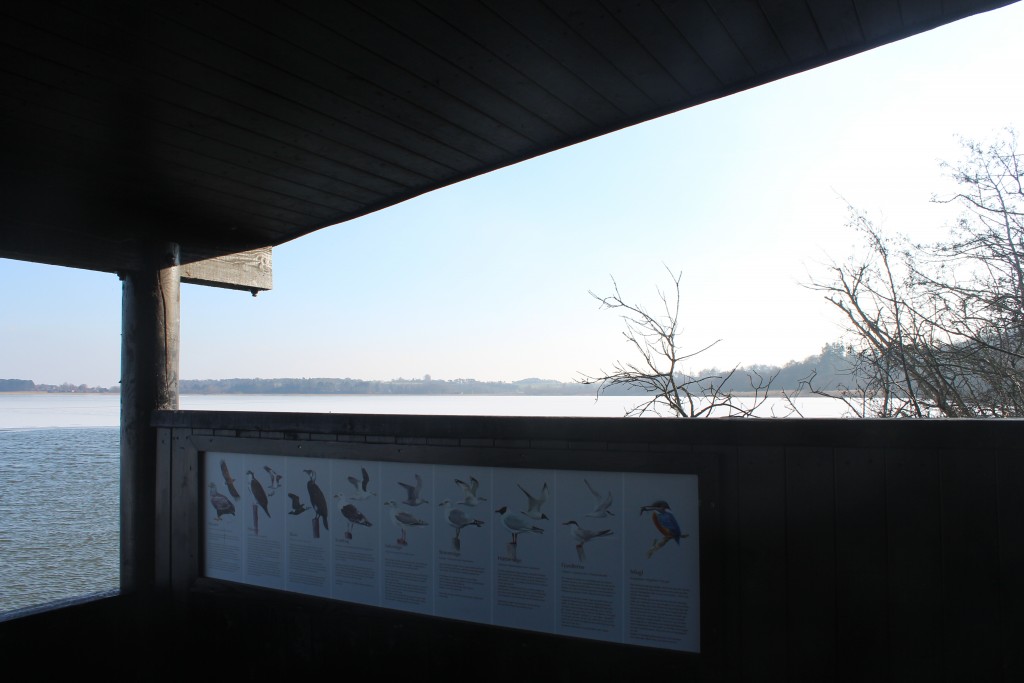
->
[785,449,836,683]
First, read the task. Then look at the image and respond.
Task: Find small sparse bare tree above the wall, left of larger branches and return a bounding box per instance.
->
[578,266,773,418]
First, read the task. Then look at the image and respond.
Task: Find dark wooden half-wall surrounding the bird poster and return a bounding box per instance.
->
[9,412,1024,682]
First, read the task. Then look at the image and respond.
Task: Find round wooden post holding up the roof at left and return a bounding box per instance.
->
[121,244,181,596]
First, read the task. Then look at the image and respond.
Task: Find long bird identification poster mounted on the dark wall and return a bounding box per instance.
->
[203,453,700,652]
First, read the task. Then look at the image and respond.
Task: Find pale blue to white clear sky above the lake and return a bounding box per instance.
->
[6,3,1024,386]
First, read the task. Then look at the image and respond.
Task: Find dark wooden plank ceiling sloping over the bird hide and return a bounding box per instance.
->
[0,0,1011,278]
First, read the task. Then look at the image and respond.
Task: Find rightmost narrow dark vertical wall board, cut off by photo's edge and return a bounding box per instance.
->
[995,451,1024,681]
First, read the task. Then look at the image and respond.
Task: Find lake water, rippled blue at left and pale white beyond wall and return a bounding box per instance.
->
[0,394,840,615]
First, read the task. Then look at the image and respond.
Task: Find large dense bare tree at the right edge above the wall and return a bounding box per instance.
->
[809,130,1024,418]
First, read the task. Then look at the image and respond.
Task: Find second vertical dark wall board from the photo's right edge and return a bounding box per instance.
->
[940,450,1000,681]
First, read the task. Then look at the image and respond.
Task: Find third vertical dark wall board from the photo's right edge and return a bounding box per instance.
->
[886,450,942,681]
